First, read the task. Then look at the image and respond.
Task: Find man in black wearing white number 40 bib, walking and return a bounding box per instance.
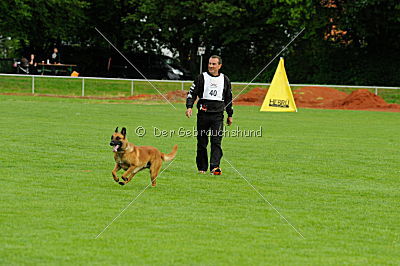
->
[185,55,233,175]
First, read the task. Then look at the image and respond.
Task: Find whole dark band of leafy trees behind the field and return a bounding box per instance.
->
[0,0,400,85]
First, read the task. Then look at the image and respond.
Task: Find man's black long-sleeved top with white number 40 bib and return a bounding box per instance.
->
[186,72,233,117]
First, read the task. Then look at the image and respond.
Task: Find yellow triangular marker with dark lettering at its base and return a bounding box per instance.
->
[260,57,297,112]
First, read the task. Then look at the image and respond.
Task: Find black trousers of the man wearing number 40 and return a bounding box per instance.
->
[196,111,224,171]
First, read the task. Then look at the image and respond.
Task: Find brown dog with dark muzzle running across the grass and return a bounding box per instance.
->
[110,127,178,187]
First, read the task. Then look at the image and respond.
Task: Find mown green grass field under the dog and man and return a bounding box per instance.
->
[0,95,400,265]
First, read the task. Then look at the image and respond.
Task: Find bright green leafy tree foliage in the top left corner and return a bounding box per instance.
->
[0,0,88,58]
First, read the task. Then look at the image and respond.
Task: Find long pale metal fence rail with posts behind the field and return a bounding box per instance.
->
[0,74,400,96]
